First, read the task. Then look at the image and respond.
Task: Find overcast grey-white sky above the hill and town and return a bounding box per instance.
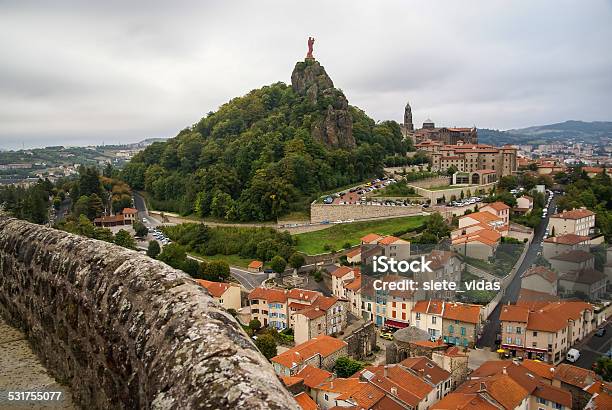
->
[0,0,612,148]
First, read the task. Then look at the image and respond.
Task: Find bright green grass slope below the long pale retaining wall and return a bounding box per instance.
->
[294,215,427,255]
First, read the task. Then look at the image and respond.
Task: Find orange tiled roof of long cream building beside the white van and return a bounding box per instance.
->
[499,301,593,332]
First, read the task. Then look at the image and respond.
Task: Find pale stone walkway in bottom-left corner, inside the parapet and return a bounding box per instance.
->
[0,318,77,409]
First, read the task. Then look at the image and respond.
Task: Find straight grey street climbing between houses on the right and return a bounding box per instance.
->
[477,195,555,348]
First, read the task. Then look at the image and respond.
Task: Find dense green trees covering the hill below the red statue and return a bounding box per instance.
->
[122,82,411,221]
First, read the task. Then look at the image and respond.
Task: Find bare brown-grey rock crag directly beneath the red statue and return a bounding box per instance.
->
[291,59,356,148]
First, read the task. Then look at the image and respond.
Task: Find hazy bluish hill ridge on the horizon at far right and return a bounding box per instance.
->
[478,121,612,145]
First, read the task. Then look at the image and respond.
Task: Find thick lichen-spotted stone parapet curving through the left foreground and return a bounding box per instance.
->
[0,217,298,409]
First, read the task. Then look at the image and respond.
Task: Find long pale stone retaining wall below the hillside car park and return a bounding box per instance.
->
[310,203,421,223]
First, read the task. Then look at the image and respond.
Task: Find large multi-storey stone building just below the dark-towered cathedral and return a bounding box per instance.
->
[415,139,517,178]
